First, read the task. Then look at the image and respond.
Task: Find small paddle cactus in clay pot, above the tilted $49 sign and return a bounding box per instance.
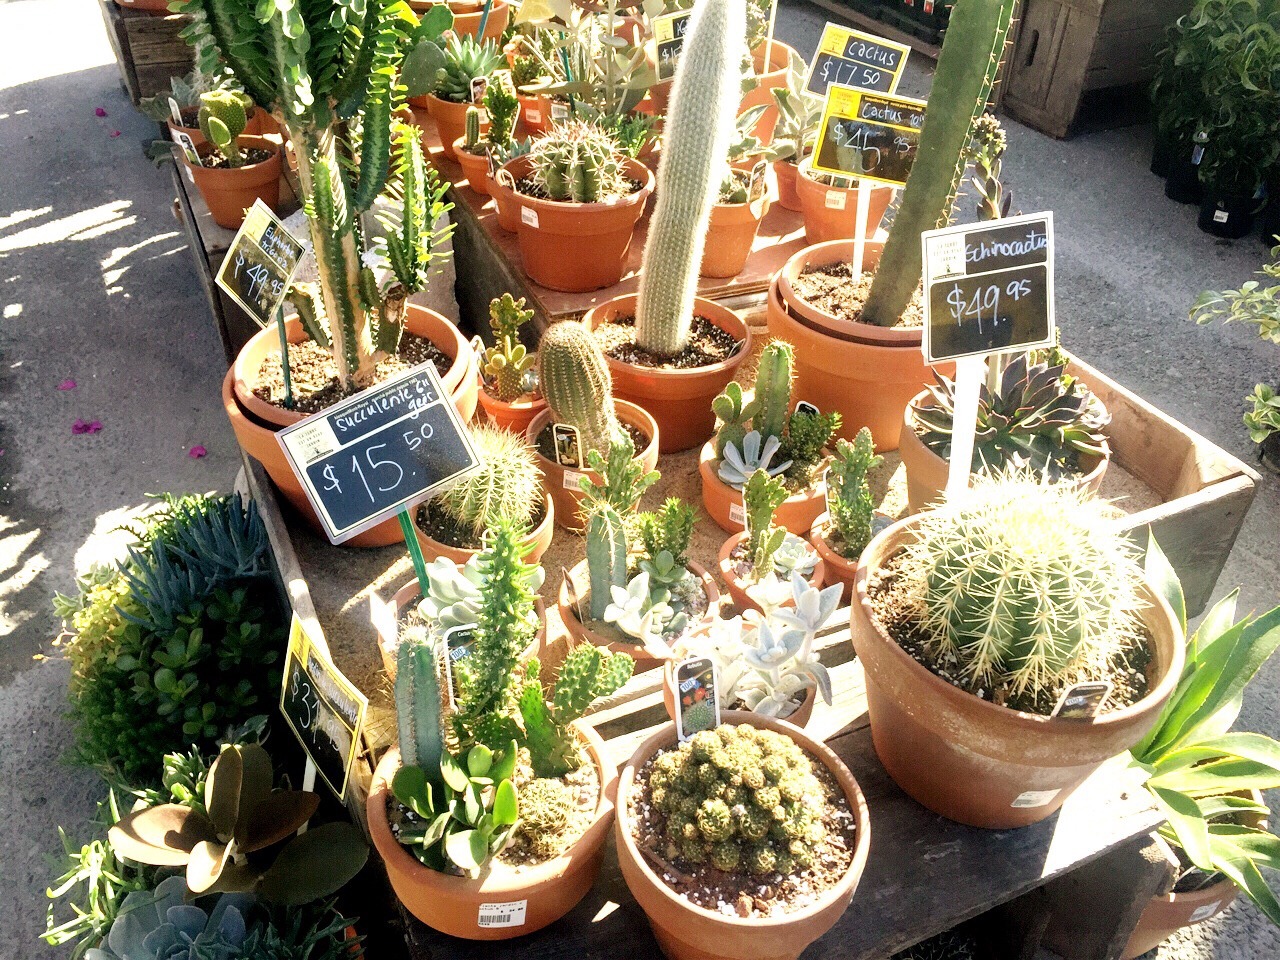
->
[178,90,280,230]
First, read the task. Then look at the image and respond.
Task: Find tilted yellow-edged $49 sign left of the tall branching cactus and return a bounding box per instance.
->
[216,200,306,326]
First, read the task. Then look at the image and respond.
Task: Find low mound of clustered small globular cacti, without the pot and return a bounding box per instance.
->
[649,724,826,877]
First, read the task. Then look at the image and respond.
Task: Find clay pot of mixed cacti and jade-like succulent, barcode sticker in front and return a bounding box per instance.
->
[367,521,632,940]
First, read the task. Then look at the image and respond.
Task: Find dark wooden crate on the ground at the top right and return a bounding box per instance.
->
[1002,0,1192,137]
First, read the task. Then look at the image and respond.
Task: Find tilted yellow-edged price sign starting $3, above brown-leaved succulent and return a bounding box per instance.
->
[280,613,369,800]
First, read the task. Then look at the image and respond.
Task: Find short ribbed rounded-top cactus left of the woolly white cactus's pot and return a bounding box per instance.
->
[538,320,622,452]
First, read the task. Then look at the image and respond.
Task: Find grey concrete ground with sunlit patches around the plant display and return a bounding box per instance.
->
[0,0,1280,960]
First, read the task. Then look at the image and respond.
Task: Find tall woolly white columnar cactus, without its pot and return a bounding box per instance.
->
[636,0,746,357]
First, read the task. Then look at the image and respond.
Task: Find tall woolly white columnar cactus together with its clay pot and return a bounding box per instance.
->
[585,0,751,453]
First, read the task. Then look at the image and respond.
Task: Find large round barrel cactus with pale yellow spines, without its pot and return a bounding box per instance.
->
[904,472,1142,695]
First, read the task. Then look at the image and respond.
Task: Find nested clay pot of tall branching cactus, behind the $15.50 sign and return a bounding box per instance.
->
[223,303,477,547]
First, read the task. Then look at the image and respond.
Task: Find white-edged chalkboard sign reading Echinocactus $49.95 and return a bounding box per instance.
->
[920,212,1053,364]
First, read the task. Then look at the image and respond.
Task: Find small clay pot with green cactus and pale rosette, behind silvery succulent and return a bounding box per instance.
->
[719,468,826,612]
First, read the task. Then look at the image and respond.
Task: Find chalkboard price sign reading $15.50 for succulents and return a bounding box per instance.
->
[276,361,480,543]
